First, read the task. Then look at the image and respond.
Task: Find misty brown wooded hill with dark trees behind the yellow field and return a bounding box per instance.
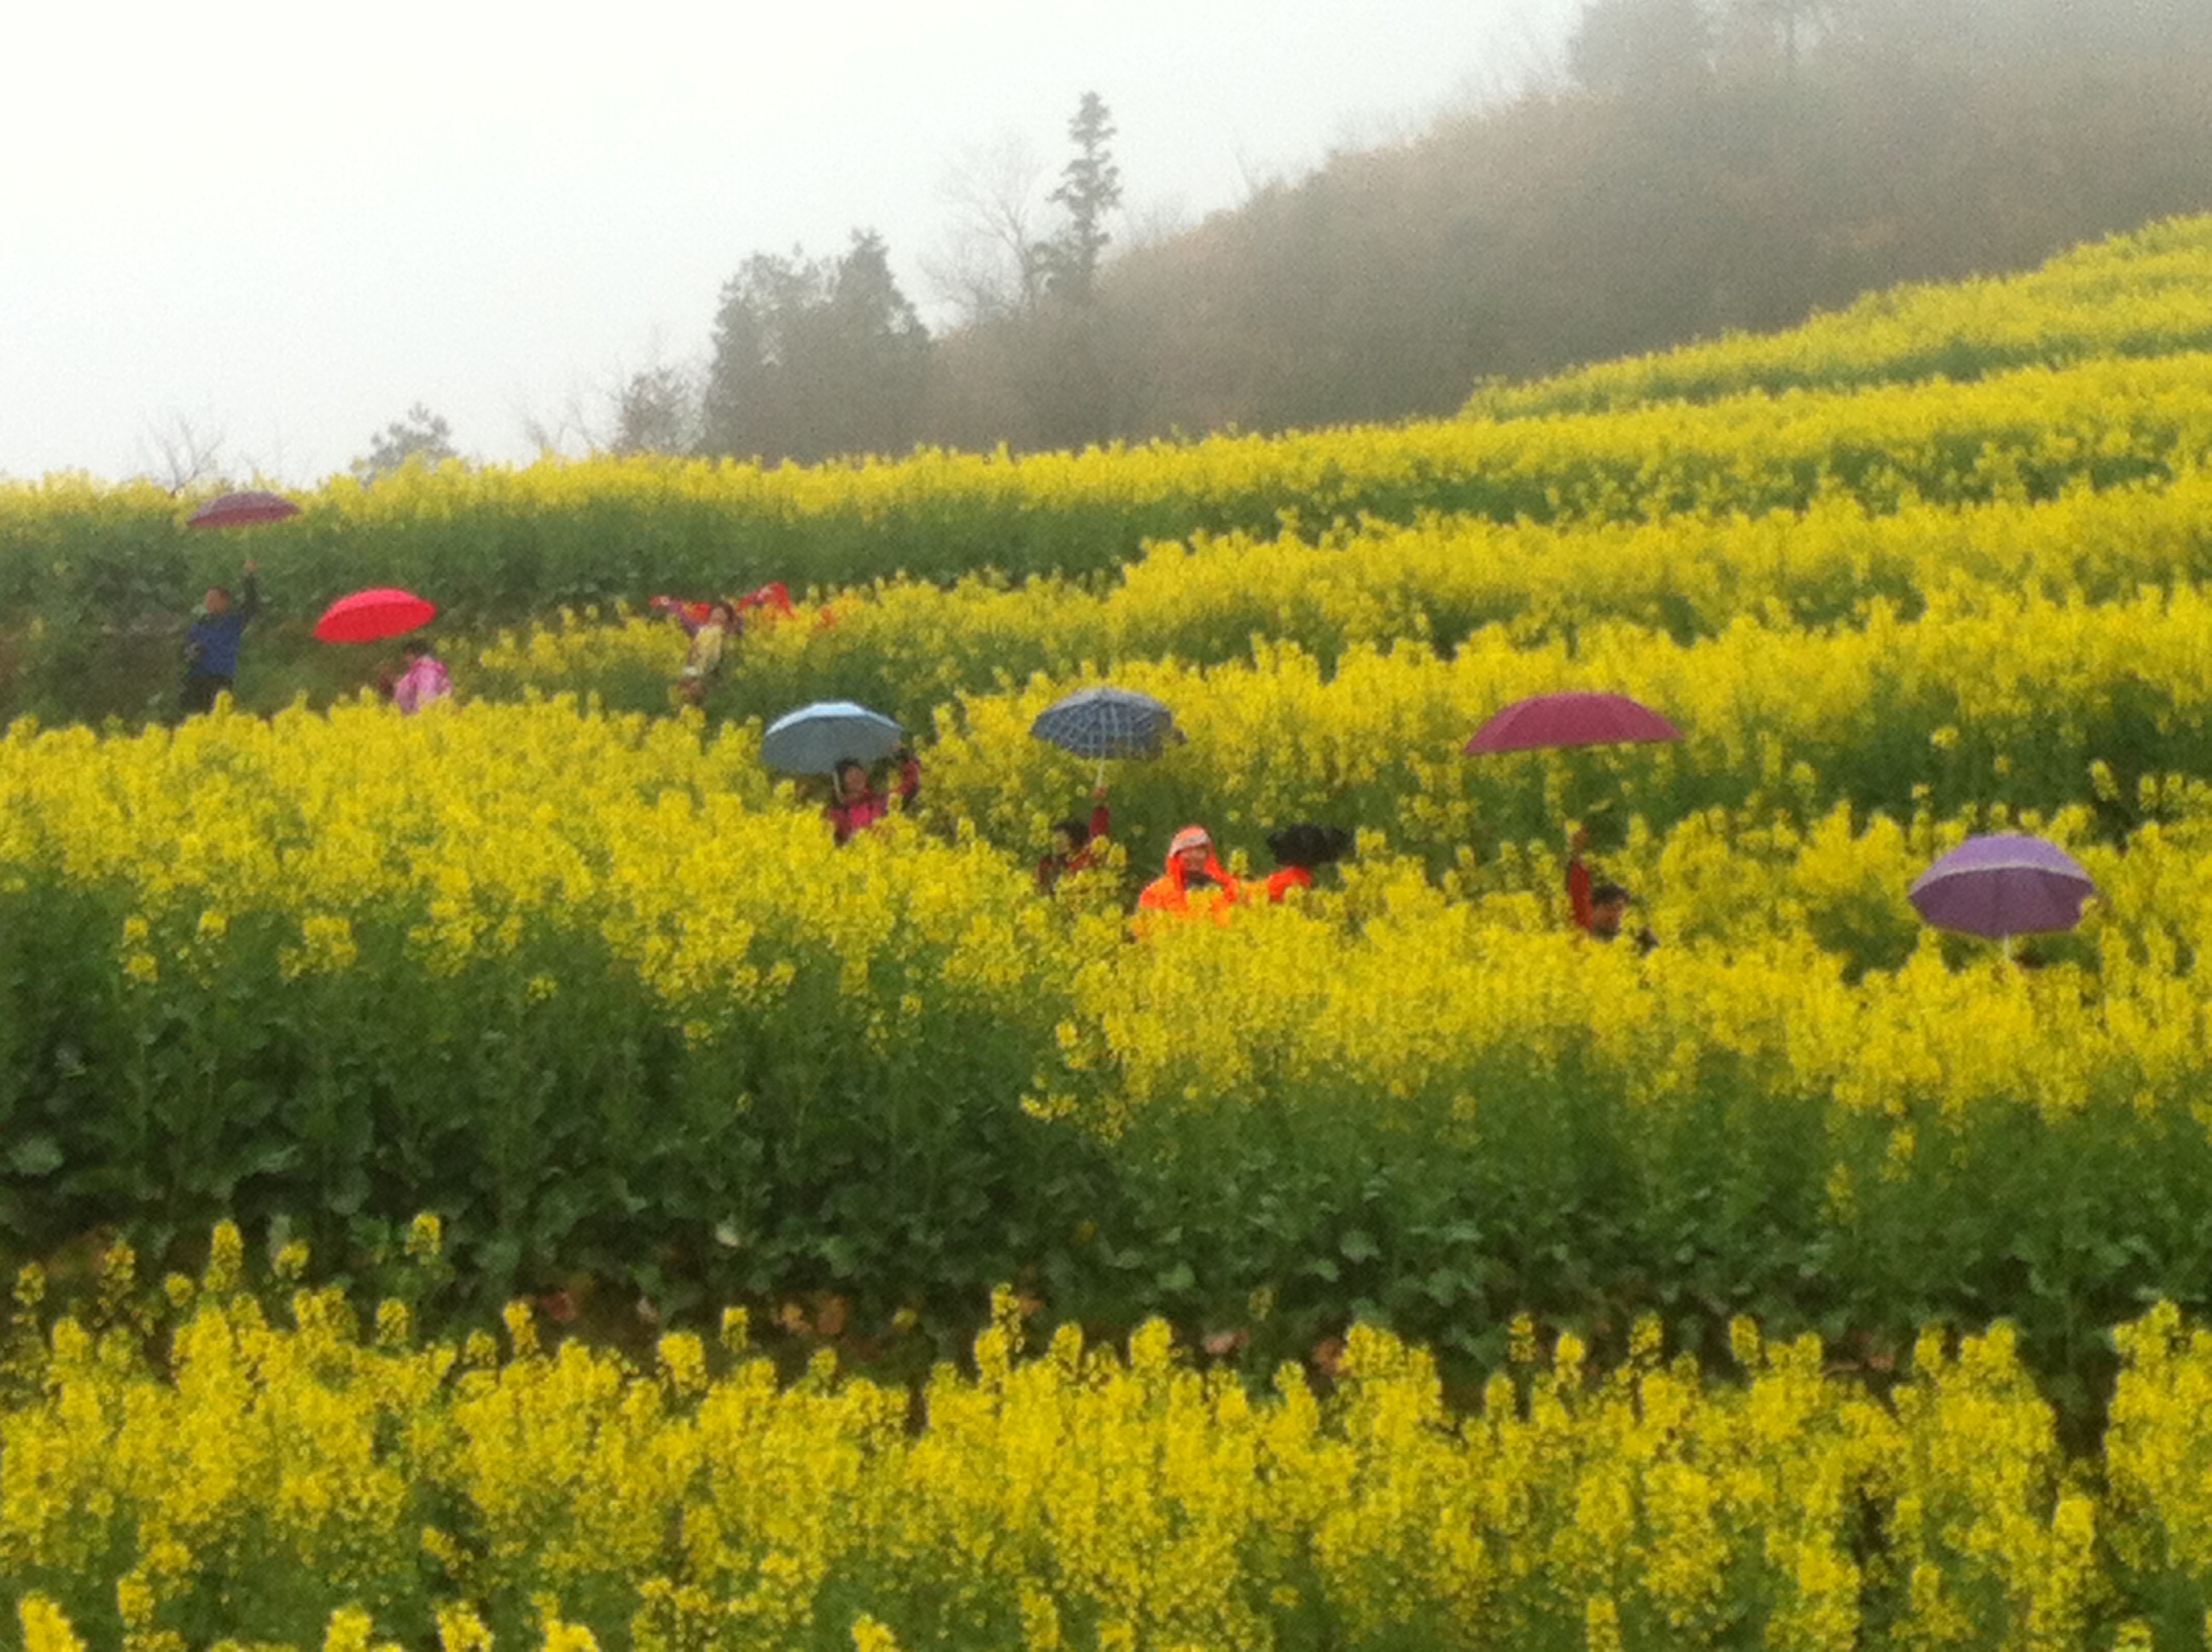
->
[579,0,2212,460]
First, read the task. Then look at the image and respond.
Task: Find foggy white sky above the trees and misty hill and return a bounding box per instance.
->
[0,0,1580,482]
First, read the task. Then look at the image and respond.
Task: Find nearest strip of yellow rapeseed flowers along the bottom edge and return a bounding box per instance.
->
[0,1230,2212,1649]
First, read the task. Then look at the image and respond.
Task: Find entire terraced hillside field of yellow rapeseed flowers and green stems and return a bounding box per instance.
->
[13,224,2212,1652]
